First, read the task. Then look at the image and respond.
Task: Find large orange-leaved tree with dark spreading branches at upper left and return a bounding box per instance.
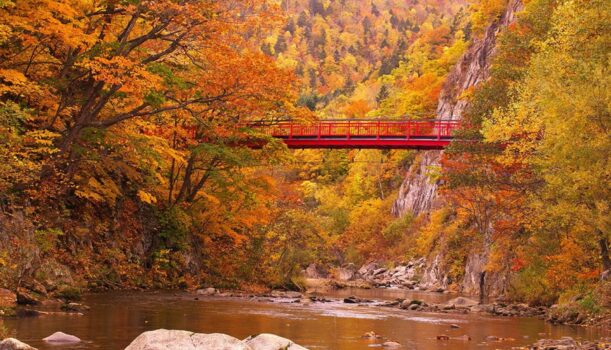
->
[0,0,282,180]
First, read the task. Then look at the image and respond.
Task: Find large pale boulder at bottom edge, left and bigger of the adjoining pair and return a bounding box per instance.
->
[125,329,252,350]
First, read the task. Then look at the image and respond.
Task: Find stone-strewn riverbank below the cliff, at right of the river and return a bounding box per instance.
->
[303,258,611,329]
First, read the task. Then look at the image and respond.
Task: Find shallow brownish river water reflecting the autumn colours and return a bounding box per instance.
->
[4,290,608,350]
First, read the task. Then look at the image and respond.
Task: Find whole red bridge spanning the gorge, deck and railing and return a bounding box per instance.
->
[249,119,459,149]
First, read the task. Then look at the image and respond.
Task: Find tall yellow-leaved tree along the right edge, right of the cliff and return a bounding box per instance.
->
[484,1,611,276]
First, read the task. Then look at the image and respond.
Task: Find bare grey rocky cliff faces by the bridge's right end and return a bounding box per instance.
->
[392,0,522,295]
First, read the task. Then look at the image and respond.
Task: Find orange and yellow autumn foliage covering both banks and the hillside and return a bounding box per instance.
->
[0,0,611,312]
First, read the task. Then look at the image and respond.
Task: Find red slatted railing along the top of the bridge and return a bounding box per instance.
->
[253,119,459,140]
